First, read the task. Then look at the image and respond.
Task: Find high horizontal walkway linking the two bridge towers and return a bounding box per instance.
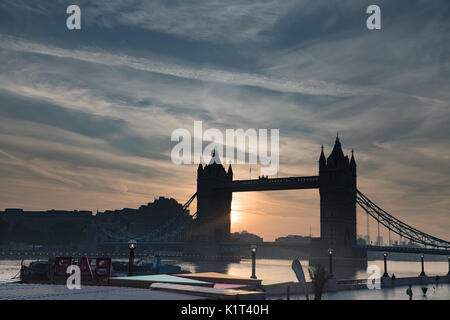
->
[216,176,319,192]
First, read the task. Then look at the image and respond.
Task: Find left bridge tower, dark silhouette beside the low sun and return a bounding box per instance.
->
[194,152,233,243]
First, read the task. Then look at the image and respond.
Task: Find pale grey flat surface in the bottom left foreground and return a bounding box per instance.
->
[0,282,201,300]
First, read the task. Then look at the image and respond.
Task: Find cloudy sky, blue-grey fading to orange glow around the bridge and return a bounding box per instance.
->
[0,0,450,240]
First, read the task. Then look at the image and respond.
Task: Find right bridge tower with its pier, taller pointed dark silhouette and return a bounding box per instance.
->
[310,136,367,268]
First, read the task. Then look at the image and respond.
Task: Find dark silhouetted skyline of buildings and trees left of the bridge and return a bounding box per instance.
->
[0,197,192,247]
